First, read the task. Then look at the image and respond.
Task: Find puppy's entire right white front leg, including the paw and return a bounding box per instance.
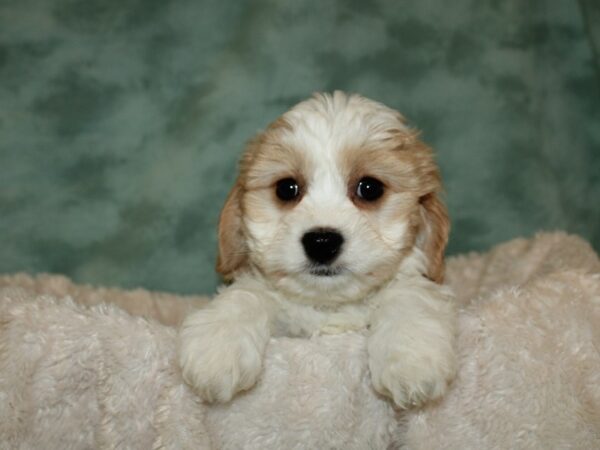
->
[368,278,456,408]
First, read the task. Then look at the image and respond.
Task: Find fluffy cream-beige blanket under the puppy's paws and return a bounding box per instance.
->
[0,233,600,450]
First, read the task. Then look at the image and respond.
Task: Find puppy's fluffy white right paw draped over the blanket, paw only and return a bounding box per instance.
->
[369,336,456,409]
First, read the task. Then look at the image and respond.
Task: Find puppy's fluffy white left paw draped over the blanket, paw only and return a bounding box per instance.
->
[179,311,268,403]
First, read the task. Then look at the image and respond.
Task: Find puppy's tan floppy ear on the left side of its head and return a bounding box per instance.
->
[217,180,247,281]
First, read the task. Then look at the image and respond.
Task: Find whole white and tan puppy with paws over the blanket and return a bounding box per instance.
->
[179,92,456,408]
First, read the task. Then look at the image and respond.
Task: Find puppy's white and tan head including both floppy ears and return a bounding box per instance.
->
[217,92,448,303]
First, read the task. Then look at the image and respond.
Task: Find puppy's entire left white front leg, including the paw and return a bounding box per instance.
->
[179,279,274,402]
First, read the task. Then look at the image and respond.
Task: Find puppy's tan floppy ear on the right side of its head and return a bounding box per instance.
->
[419,193,450,283]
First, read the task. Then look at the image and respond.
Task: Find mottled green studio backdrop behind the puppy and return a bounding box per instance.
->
[0,0,600,293]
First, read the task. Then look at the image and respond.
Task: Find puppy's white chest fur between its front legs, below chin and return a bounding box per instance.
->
[275,300,369,337]
